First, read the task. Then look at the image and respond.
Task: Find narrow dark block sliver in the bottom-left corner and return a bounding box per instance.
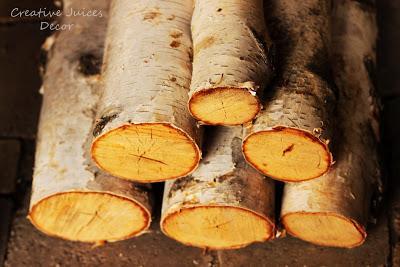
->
[0,197,13,266]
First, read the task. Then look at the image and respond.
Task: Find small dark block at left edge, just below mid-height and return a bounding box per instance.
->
[0,139,20,194]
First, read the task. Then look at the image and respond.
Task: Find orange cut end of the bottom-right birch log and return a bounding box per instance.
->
[282,212,366,248]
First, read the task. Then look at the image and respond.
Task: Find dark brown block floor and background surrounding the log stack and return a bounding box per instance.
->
[0,0,400,266]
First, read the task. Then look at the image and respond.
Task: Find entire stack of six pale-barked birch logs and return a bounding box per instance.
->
[29,0,380,249]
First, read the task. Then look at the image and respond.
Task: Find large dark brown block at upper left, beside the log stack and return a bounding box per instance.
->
[0,23,49,138]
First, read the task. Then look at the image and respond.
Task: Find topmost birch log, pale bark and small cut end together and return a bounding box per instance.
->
[189,0,271,125]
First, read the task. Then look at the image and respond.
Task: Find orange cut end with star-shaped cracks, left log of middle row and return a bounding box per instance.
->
[92,123,200,182]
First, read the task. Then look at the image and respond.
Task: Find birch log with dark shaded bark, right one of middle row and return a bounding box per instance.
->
[243,0,335,182]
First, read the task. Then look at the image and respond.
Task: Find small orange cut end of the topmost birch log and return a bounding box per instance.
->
[189,87,261,125]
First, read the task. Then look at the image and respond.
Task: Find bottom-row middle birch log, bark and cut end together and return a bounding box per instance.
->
[161,126,274,249]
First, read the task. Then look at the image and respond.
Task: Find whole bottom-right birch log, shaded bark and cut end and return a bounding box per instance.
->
[281,0,380,247]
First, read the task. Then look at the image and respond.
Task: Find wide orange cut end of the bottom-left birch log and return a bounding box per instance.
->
[29,192,151,243]
